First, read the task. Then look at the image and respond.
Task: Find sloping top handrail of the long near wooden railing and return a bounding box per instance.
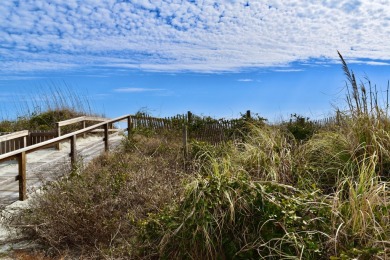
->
[0,115,131,162]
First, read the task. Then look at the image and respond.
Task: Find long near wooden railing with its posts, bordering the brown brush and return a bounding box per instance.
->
[0,115,132,200]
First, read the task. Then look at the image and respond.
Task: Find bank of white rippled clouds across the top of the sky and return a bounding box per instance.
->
[0,0,390,74]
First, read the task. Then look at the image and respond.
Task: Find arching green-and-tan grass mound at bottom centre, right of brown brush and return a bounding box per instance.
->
[143,155,329,259]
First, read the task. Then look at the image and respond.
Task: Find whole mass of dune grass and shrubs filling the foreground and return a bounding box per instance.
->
[3,57,390,259]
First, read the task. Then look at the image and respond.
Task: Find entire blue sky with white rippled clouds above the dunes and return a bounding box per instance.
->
[0,0,390,121]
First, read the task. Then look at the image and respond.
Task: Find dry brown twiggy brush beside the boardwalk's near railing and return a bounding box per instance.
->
[7,133,184,258]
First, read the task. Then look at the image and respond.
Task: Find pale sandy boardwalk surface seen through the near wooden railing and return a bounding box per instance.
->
[0,133,124,210]
